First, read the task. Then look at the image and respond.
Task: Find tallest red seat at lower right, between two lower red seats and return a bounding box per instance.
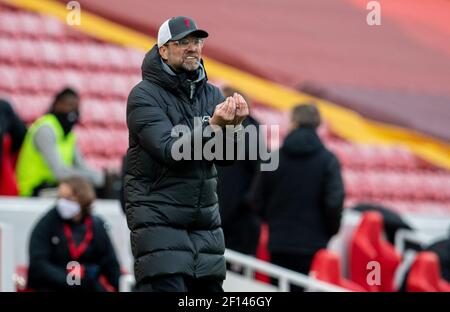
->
[350,212,401,291]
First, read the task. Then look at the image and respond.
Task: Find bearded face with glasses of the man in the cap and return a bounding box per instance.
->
[159,35,203,71]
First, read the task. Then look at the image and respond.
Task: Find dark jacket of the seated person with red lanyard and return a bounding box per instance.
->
[28,208,120,291]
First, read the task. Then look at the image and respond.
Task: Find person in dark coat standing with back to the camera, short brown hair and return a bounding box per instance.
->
[253,105,344,291]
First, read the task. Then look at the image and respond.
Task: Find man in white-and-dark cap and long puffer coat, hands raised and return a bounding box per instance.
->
[124,16,249,292]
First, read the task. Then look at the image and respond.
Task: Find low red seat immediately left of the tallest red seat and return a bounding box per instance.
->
[309,249,366,292]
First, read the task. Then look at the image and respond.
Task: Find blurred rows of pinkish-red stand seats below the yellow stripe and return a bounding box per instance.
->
[0,4,450,214]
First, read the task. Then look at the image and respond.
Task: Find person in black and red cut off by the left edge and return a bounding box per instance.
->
[0,99,27,196]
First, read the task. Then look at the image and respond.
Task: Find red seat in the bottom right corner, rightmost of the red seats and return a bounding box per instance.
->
[406,251,450,292]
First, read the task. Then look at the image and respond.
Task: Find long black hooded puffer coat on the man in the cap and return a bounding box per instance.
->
[124,46,226,283]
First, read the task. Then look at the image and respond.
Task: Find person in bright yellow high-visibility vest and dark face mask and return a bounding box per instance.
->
[16,88,105,196]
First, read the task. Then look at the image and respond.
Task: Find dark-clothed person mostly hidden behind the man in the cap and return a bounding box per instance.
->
[216,87,264,255]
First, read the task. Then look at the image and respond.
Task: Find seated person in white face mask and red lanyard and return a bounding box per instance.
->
[27,177,120,291]
